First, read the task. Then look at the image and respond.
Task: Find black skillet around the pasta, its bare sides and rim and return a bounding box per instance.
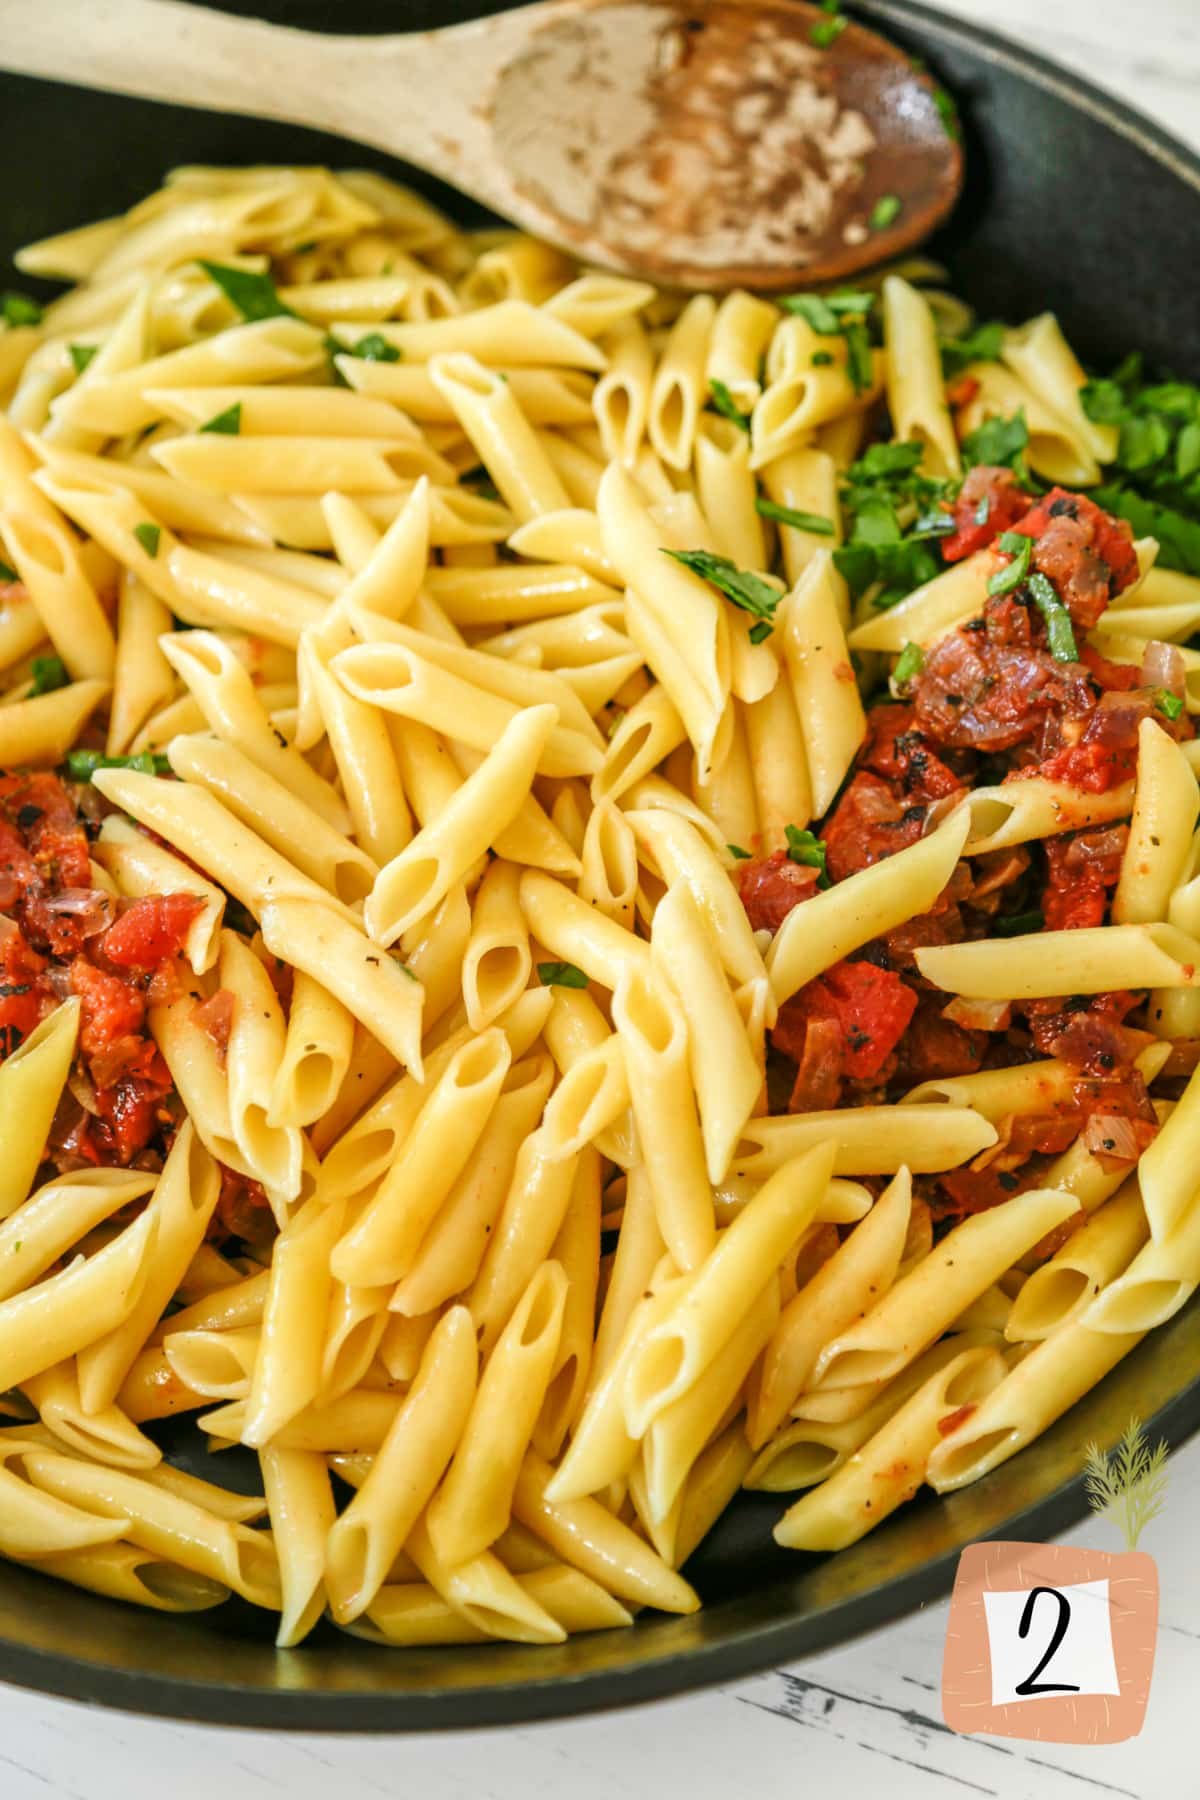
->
[0,0,1200,1732]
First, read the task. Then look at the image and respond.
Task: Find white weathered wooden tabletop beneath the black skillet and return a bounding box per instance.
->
[0,0,1200,1800]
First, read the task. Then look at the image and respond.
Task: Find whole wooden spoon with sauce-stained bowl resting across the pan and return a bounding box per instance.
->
[0,0,963,288]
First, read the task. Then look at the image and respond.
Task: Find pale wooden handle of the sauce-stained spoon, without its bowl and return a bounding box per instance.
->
[0,0,539,203]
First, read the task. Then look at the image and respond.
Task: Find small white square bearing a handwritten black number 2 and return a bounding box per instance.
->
[984,1579,1121,1706]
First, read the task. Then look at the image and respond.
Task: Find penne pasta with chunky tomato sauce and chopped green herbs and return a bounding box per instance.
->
[0,167,1200,1645]
